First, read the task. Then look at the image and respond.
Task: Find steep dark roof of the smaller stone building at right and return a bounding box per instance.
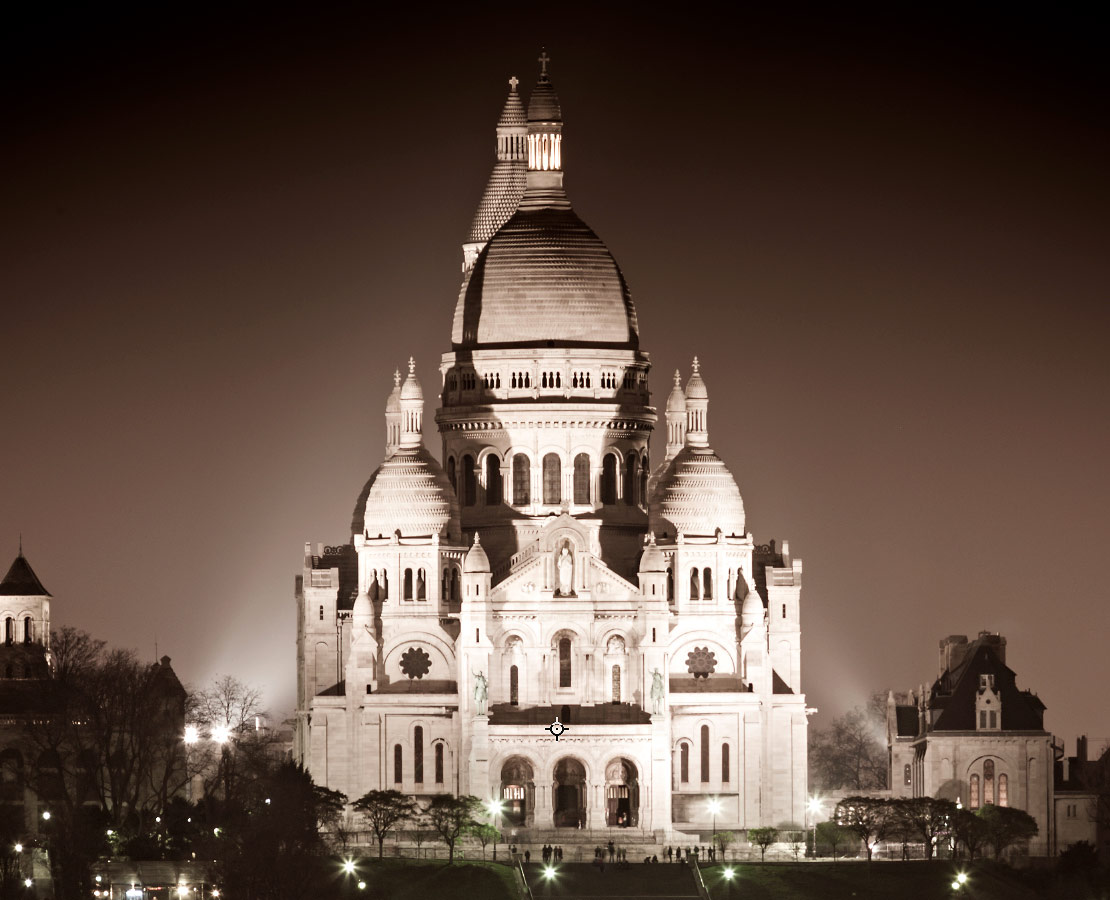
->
[927,639,1045,731]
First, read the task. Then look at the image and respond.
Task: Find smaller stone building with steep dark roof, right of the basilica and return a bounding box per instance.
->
[887,631,1055,856]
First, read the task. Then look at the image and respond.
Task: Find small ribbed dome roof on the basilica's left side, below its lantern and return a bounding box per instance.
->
[352,446,461,539]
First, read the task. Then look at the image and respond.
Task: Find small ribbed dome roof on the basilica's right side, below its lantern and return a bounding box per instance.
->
[650,446,745,535]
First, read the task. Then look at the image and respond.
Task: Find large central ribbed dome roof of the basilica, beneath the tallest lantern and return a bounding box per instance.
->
[451,201,639,348]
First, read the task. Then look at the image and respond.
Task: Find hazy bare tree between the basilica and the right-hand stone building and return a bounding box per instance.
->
[809,707,888,790]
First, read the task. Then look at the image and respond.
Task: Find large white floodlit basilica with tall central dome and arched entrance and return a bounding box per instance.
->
[295,60,807,832]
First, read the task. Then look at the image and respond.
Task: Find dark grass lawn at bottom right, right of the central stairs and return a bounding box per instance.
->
[702,860,1102,900]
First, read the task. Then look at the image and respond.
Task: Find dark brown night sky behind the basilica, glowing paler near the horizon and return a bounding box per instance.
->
[0,3,1110,747]
